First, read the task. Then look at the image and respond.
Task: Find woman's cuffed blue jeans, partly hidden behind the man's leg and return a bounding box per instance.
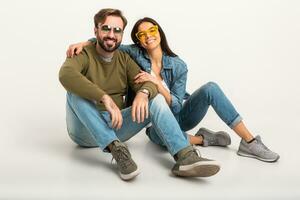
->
[147,82,242,146]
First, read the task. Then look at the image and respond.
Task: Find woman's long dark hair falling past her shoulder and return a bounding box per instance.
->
[131,17,177,57]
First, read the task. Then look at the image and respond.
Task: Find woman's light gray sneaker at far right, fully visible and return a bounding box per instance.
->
[237,135,280,162]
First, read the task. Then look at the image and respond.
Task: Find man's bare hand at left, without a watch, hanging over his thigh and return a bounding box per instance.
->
[101,94,123,130]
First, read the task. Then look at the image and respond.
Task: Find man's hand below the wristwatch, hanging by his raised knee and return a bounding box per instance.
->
[131,92,148,123]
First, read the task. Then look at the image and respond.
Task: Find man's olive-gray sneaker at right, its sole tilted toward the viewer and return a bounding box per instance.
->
[172,146,220,177]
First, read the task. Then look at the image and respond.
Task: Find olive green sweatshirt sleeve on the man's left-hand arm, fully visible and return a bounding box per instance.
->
[59,51,105,101]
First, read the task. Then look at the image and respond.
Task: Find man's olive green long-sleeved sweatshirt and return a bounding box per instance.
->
[59,44,157,110]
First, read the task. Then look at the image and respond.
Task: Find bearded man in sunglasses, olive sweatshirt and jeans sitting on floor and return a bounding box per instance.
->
[59,9,220,180]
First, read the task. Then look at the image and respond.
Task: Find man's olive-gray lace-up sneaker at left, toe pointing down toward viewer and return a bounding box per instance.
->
[111,141,139,180]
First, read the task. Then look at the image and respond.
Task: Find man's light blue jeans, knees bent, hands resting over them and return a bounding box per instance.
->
[66,92,189,156]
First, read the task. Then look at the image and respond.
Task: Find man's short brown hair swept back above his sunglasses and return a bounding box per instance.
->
[94,8,127,29]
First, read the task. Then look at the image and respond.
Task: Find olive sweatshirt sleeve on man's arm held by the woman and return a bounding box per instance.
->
[127,56,157,99]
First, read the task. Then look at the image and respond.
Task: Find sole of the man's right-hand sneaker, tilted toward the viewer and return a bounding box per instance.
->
[172,161,220,177]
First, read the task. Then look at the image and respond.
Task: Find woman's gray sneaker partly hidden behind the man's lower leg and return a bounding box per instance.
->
[195,128,231,147]
